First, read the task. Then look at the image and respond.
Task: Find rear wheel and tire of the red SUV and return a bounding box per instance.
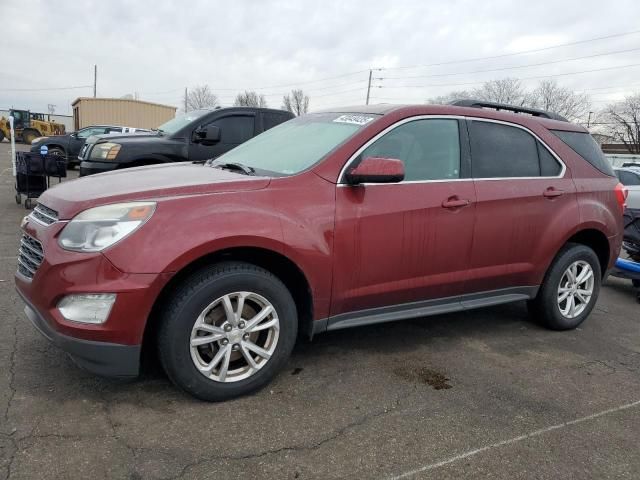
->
[528,243,602,330]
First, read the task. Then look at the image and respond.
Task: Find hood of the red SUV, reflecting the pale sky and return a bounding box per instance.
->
[38,163,271,220]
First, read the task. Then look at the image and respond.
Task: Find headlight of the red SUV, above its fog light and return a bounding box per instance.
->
[58,202,156,252]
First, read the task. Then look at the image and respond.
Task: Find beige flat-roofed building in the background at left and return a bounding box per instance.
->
[71,97,176,130]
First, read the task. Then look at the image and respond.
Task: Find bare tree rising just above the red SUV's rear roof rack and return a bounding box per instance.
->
[530,80,591,121]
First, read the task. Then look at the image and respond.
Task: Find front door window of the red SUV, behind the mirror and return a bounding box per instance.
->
[360,119,460,181]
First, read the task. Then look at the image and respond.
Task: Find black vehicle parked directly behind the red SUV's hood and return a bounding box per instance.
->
[79,107,293,176]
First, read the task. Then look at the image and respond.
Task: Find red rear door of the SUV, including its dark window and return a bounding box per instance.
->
[467,119,579,292]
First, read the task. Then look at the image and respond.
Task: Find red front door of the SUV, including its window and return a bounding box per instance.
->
[331,117,475,315]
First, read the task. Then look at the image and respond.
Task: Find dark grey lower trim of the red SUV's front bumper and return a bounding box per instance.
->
[18,291,141,378]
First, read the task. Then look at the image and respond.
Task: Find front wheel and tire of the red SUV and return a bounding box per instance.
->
[157,262,298,402]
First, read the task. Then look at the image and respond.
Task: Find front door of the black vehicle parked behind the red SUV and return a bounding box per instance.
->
[189,112,256,161]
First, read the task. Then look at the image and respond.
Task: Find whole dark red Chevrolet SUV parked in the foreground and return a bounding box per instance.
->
[16,101,625,400]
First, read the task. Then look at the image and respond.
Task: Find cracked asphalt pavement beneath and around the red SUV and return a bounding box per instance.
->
[0,142,640,479]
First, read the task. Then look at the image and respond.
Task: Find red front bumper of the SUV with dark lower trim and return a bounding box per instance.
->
[15,220,171,377]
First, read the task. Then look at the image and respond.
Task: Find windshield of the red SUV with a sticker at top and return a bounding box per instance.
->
[216,113,378,175]
